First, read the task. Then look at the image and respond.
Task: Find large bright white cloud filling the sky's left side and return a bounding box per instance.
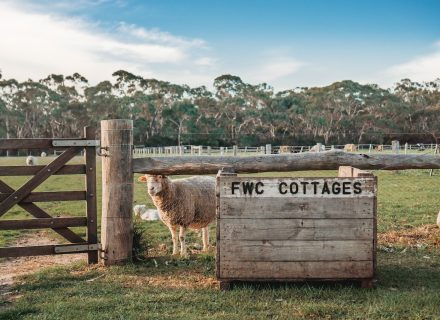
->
[0,1,214,84]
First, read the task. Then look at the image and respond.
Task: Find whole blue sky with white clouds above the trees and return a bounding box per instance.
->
[0,0,440,91]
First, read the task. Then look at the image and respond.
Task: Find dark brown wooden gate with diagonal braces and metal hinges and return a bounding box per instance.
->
[0,127,99,263]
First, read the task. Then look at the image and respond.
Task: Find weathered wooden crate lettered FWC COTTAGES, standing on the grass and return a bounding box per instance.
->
[216,167,376,289]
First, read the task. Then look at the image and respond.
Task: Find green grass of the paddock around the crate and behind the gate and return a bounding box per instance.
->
[0,158,440,320]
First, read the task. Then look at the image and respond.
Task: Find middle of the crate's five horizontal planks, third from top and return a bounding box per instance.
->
[219,219,373,240]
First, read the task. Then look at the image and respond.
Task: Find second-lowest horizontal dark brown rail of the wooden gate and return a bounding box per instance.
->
[0,217,87,230]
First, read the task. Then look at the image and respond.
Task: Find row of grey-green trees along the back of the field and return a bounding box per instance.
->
[0,70,440,146]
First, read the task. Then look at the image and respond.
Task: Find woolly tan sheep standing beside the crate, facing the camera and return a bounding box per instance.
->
[138,175,216,257]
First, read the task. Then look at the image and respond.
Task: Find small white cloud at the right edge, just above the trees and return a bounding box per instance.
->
[385,42,440,81]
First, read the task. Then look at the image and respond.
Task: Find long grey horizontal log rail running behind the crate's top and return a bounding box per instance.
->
[133,151,440,175]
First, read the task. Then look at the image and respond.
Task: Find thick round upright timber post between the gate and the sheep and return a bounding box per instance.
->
[101,119,133,265]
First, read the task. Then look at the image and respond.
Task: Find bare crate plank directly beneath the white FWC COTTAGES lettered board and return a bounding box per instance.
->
[219,198,374,219]
